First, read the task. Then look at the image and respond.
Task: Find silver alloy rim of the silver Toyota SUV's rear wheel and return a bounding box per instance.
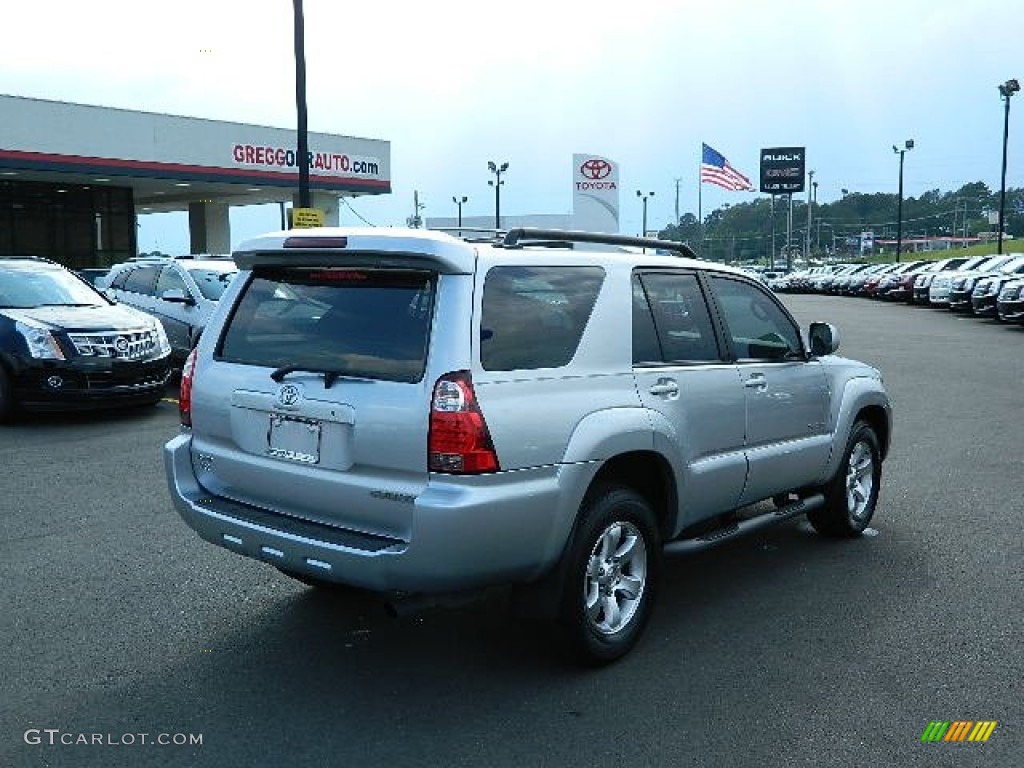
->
[584,522,647,635]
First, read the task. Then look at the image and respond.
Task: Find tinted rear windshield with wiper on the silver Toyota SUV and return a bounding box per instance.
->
[217,267,436,382]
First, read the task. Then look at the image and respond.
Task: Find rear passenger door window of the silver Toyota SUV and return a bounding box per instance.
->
[634,272,721,362]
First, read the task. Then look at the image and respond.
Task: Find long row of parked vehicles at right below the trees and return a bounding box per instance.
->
[768,254,1024,325]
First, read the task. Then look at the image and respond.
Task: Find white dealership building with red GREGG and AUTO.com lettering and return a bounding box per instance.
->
[0,94,391,268]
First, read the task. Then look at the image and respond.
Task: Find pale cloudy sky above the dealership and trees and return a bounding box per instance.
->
[0,0,1024,252]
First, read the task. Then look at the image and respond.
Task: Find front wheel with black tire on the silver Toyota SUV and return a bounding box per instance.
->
[807,422,882,538]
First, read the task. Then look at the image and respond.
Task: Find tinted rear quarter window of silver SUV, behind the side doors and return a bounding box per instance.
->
[480,266,604,371]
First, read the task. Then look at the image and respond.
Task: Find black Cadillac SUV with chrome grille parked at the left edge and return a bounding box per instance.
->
[0,256,170,421]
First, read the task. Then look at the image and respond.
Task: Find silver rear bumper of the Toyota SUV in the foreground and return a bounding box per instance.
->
[164,434,579,593]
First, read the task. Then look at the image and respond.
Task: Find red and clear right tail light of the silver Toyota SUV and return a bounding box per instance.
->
[427,371,499,474]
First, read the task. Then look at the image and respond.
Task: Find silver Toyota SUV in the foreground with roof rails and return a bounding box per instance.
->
[165,228,891,664]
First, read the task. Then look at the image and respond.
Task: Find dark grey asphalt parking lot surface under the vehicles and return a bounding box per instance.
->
[0,296,1024,768]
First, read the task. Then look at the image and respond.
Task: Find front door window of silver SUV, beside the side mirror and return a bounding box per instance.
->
[711,276,803,360]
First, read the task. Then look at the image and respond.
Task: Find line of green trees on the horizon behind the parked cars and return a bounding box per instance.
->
[658,181,1024,261]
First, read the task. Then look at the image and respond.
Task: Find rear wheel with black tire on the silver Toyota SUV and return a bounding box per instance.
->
[558,486,662,666]
